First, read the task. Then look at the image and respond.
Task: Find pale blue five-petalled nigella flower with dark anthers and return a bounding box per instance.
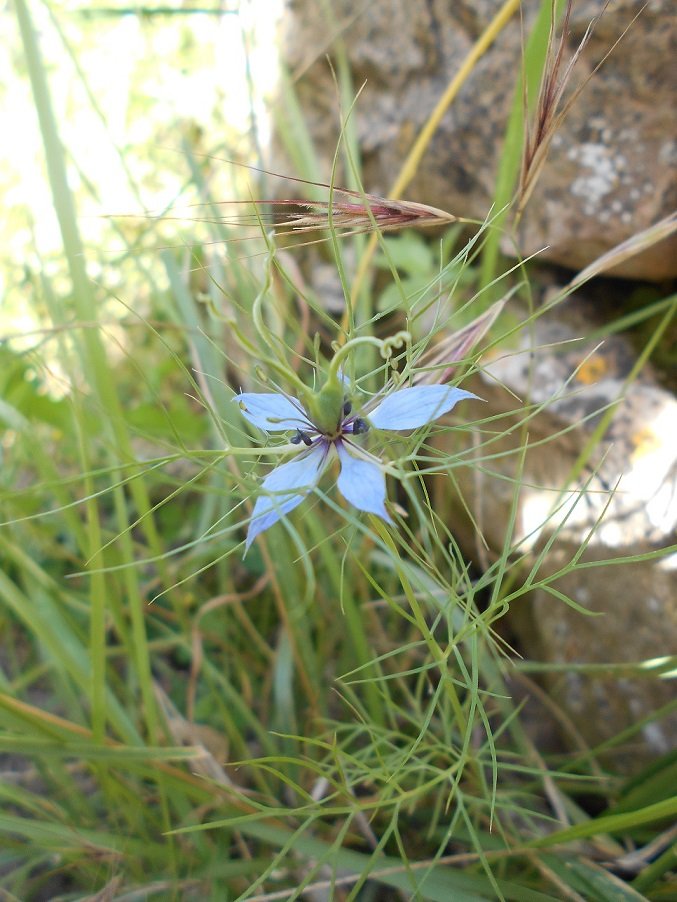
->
[233,385,477,549]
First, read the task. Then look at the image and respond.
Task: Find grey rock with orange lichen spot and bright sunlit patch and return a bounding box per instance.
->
[478,301,677,556]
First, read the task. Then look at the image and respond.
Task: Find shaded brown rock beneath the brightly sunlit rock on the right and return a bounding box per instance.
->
[518,543,677,771]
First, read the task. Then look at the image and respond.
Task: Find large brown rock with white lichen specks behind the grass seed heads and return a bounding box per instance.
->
[283,0,677,280]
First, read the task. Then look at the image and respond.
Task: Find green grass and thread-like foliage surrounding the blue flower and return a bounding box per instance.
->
[0,0,677,902]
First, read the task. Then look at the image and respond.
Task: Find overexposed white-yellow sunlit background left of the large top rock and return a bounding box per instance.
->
[0,0,281,356]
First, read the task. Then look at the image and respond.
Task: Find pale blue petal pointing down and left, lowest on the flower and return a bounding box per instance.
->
[245,439,329,553]
